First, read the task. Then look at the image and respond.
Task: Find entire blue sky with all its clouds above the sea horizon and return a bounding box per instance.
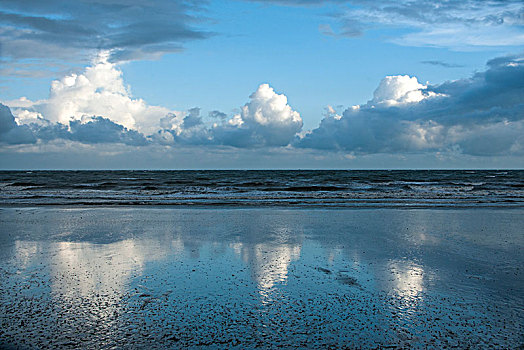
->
[0,0,524,169]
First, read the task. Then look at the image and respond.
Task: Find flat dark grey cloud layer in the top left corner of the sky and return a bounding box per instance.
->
[0,0,211,73]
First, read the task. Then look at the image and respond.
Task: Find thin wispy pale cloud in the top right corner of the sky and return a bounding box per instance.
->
[321,0,524,50]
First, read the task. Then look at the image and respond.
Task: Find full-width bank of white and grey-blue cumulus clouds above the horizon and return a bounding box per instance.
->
[0,56,524,157]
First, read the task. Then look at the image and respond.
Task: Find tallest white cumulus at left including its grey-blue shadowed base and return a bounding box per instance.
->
[2,52,161,146]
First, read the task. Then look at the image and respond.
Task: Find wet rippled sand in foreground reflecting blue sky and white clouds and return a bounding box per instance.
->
[0,208,524,349]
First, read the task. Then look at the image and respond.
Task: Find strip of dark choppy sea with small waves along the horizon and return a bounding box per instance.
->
[0,170,524,208]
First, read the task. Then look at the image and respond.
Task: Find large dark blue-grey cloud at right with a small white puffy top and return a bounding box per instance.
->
[295,57,524,156]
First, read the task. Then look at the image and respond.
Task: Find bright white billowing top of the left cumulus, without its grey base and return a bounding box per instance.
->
[9,52,171,133]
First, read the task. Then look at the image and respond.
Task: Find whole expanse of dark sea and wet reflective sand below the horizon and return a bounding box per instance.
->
[0,170,524,349]
